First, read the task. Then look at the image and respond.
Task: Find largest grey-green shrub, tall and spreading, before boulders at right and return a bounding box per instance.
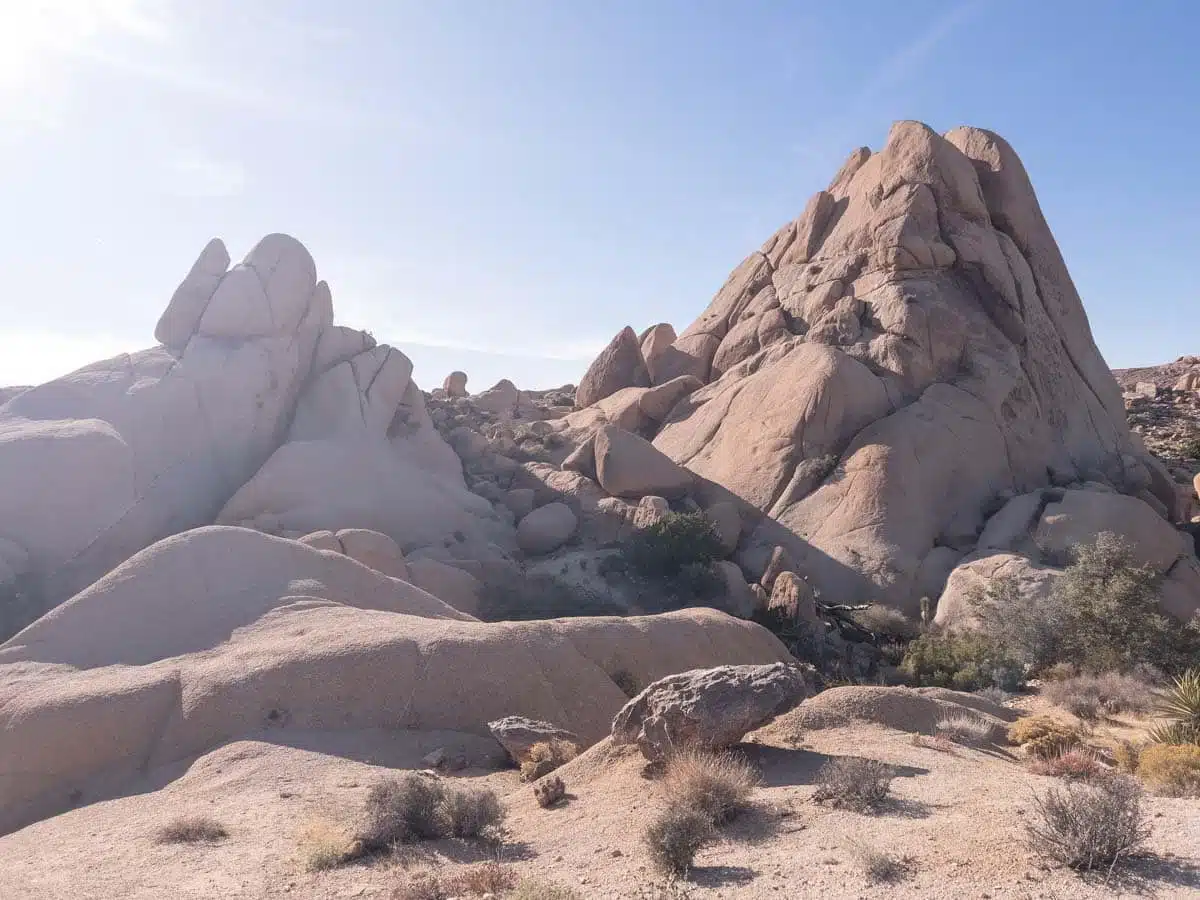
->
[971,532,1200,674]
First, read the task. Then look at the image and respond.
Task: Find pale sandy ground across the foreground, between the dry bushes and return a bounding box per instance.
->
[0,701,1200,900]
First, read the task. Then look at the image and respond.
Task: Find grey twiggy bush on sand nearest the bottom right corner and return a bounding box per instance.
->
[1026,775,1150,871]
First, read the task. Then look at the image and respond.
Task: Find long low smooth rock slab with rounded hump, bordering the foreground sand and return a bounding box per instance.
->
[0,527,787,832]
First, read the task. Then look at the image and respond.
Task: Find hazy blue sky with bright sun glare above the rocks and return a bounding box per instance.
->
[0,0,1200,391]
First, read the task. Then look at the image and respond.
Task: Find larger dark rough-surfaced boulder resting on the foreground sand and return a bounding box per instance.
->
[612,662,812,761]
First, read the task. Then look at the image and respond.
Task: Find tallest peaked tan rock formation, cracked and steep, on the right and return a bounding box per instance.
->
[571,122,1152,613]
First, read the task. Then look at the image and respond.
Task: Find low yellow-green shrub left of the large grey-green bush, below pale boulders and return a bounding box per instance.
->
[900,631,1024,691]
